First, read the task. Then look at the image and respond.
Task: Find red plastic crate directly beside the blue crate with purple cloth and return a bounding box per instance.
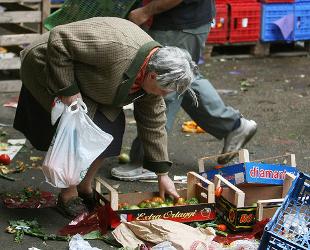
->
[229,2,261,43]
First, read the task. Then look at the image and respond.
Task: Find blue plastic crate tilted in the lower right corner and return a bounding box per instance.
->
[259,173,310,250]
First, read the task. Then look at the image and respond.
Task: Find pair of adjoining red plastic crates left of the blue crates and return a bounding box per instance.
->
[207,0,261,44]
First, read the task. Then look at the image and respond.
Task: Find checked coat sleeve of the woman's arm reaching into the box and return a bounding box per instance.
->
[134,95,172,173]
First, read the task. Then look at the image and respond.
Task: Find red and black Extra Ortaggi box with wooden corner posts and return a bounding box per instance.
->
[96,172,216,228]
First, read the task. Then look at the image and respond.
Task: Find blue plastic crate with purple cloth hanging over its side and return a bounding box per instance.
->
[261,3,294,42]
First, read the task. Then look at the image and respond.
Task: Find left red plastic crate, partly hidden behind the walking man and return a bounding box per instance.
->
[207,4,228,43]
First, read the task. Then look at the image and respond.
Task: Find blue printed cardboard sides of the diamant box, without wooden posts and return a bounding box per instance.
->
[200,162,298,185]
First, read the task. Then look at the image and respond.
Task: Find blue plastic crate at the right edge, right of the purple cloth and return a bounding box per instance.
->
[294,2,310,41]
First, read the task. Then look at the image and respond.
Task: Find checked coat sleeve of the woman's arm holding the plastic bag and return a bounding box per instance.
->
[46,28,79,96]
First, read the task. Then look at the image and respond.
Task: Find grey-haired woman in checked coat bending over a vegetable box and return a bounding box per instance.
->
[14,17,197,218]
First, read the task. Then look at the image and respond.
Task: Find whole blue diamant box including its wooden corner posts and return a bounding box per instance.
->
[198,149,298,185]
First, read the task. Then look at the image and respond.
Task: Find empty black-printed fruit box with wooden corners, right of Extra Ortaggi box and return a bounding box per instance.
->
[214,174,295,232]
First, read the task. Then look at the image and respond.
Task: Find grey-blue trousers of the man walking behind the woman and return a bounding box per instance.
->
[148,24,240,139]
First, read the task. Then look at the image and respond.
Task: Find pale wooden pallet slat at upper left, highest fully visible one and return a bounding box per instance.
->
[0,11,42,23]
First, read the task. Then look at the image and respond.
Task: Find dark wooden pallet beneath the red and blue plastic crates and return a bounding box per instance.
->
[204,41,310,59]
